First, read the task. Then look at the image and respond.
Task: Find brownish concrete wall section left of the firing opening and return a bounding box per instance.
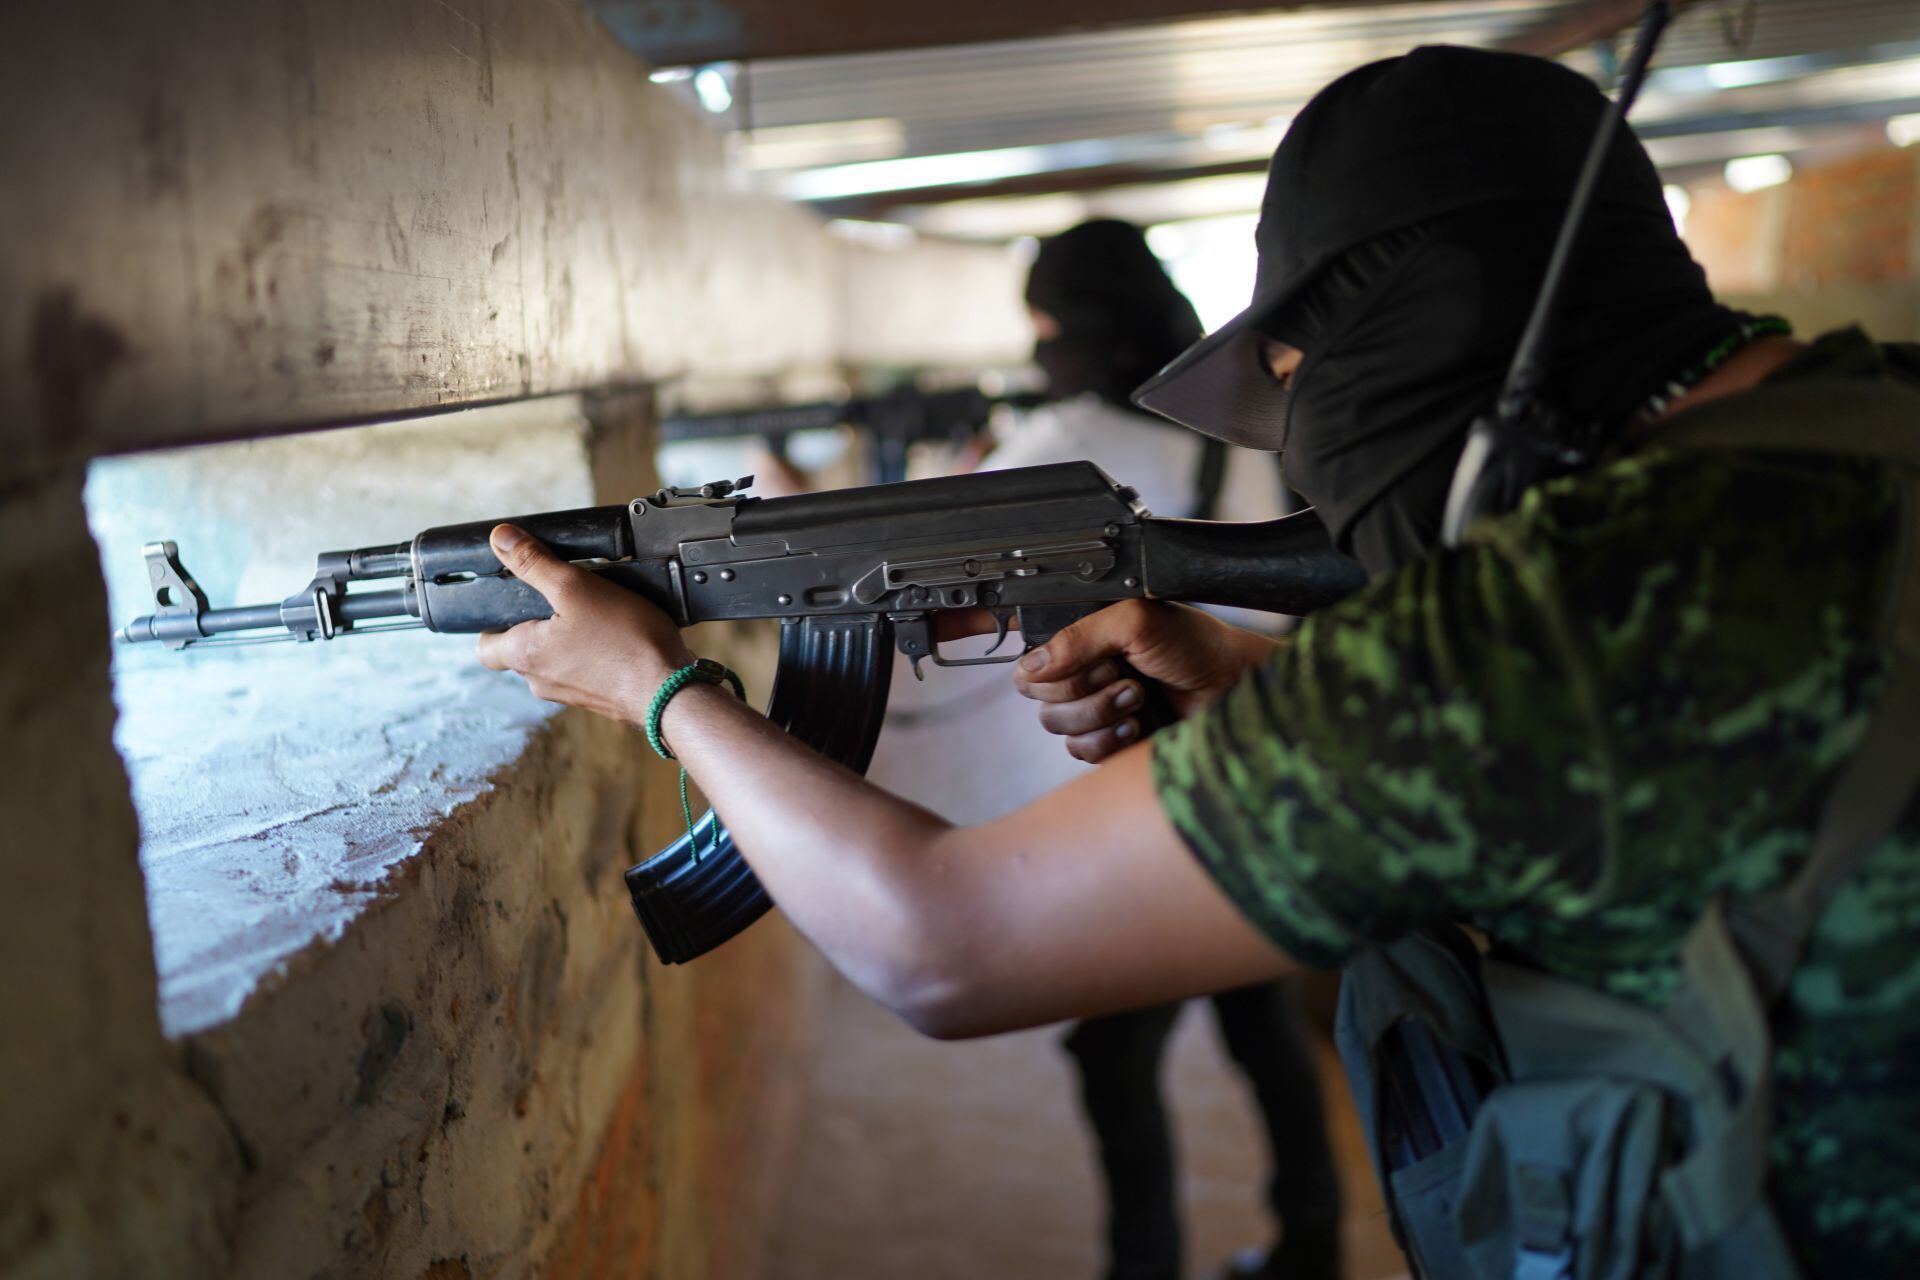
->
[0,468,240,1276]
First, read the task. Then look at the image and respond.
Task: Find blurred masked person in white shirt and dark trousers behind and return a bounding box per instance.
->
[868,219,1340,1280]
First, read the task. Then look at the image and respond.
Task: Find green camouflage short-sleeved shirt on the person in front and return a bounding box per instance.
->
[1154,330,1920,1278]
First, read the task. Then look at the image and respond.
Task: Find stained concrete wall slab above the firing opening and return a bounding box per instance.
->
[0,0,1020,462]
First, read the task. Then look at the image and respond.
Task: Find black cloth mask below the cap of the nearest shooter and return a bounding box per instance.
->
[1261,201,1745,576]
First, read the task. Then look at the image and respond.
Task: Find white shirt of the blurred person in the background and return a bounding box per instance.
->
[868,395,1283,825]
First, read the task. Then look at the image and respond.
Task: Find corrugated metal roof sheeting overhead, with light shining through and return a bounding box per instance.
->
[648,0,1920,233]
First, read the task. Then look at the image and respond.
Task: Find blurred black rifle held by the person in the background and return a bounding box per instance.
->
[660,388,1044,484]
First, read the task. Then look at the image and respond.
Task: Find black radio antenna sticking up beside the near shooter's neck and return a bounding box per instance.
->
[1440,0,1674,547]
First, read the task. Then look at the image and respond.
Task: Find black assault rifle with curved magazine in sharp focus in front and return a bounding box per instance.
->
[119,462,1365,963]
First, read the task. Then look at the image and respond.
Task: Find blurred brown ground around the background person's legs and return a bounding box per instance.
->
[766,979,1407,1280]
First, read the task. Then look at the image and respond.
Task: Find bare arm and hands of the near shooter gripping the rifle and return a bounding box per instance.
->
[478,526,1284,1036]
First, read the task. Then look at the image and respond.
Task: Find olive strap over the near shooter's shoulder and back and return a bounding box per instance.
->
[1635,378,1920,1274]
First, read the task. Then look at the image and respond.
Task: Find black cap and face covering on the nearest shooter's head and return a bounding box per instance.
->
[1135,46,1743,574]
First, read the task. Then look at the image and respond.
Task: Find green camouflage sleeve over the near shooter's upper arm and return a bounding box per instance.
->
[1154,525,1609,965]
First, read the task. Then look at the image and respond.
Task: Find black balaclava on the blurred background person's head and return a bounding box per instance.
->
[1027,219,1200,409]
